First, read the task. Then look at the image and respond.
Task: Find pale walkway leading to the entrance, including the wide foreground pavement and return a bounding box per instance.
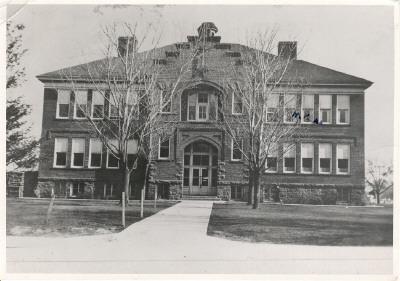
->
[7,201,392,274]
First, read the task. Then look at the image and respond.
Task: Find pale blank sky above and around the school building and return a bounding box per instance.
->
[7,5,394,165]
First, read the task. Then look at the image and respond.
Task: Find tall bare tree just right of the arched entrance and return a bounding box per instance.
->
[220,30,312,208]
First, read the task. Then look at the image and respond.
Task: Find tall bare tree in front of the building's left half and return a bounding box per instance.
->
[61,23,193,203]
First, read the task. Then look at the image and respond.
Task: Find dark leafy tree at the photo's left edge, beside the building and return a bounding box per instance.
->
[6,22,38,169]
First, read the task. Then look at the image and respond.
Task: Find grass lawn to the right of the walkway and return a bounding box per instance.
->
[207,203,393,246]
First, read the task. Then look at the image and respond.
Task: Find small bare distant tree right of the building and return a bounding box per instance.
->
[365,161,393,205]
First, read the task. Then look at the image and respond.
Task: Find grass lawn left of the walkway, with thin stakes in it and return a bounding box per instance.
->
[6,198,176,236]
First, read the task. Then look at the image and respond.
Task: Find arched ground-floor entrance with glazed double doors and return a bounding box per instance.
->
[183,140,218,195]
